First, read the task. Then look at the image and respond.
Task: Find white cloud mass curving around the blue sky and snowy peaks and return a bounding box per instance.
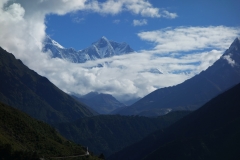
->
[0,0,240,100]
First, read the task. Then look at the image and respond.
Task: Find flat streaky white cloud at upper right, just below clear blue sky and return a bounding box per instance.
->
[138,26,240,53]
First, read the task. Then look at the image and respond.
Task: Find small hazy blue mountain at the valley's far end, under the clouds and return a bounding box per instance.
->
[73,92,125,114]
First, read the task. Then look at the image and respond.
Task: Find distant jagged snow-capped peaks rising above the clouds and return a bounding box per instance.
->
[43,36,134,63]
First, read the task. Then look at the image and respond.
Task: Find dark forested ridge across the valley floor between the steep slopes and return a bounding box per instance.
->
[56,111,189,156]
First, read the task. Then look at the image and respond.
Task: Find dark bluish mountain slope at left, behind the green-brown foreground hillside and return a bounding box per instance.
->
[0,48,93,124]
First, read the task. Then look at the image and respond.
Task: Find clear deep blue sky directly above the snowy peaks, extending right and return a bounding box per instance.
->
[46,0,240,51]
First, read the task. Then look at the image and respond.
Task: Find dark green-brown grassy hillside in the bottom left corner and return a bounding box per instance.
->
[0,102,100,160]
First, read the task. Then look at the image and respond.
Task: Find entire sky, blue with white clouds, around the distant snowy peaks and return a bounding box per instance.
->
[0,0,240,101]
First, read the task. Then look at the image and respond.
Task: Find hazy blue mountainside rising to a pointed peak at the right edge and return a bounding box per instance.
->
[118,38,240,115]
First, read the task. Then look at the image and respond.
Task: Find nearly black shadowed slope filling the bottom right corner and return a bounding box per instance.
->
[109,84,240,160]
